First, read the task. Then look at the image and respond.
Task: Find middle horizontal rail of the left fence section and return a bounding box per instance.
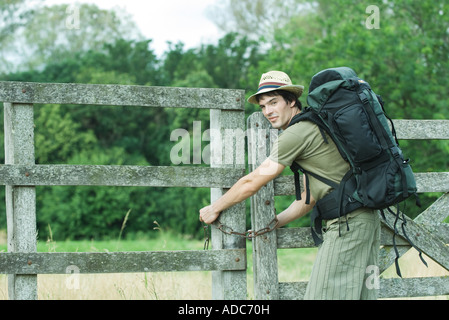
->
[0,165,245,188]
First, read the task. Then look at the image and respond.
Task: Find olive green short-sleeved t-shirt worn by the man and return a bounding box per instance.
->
[269,121,349,201]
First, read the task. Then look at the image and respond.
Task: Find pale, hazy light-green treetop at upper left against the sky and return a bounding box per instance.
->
[0,0,142,70]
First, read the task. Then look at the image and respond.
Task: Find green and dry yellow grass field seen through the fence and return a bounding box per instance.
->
[0,229,449,300]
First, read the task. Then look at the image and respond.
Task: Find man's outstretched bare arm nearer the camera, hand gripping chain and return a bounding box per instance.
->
[200,158,285,224]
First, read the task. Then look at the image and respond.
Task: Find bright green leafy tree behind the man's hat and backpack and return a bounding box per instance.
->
[248,0,449,218]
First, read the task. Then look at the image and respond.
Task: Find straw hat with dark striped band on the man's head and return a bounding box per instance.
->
[248,71,304,104]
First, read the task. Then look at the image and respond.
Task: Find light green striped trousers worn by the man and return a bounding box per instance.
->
[304,208,380,300]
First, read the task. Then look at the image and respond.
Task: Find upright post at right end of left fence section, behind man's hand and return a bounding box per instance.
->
[210,110,247,300]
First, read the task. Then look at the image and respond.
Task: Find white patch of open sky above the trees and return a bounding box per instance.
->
[43,0,223,56]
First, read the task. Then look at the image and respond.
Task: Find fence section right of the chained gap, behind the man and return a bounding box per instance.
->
[248,113,449,299]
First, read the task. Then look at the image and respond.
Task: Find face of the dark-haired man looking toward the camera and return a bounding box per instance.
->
[259,94,295,130]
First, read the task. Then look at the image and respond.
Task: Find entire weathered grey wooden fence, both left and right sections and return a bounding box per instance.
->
[0,82,449,300]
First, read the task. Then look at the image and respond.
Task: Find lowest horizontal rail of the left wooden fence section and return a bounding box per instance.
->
[0,249,246,275]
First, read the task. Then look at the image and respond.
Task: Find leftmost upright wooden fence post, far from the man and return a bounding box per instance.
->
[4,103,37,300]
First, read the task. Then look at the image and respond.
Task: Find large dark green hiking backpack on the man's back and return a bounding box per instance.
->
[289,67,427,276]
